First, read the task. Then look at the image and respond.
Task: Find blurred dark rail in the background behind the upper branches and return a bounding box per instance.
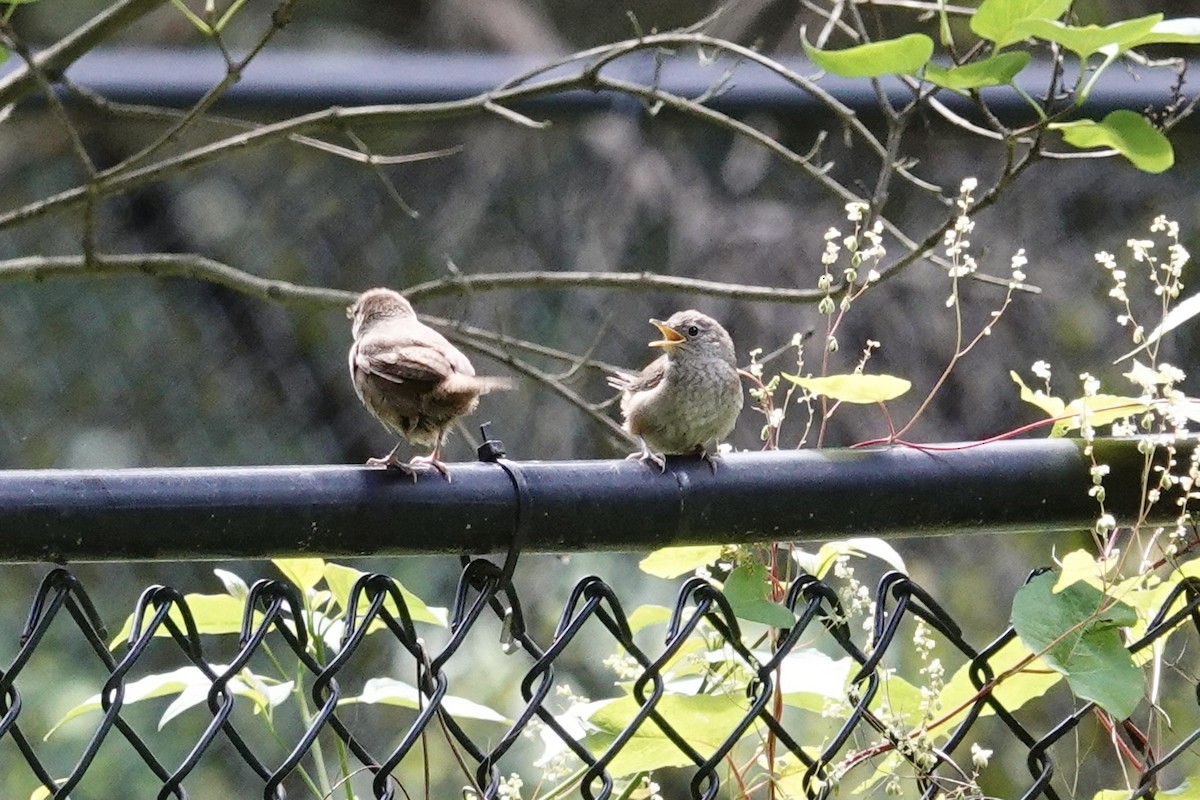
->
[0,47,1187,118]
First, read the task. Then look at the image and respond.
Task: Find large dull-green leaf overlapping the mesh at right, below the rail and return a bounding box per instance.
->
[1013,572,1145,720]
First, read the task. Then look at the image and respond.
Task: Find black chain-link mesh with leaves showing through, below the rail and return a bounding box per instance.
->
[0,559,1200,800]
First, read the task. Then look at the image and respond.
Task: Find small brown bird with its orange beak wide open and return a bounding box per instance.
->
[608,309,742,471]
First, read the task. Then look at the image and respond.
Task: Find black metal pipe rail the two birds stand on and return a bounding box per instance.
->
[0,439,1193,561]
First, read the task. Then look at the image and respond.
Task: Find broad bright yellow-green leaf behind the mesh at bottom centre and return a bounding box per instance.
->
[583,694,752,777]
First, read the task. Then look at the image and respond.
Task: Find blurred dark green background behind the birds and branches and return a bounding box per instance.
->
[0,0,1200,798]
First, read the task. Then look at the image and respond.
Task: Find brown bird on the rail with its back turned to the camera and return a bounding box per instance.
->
[346,289,512,481]
